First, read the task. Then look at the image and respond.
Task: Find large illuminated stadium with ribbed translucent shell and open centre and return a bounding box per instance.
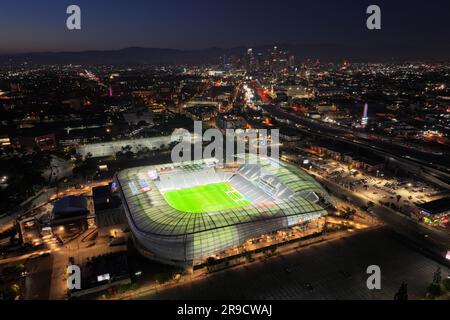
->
[113,155,332,267]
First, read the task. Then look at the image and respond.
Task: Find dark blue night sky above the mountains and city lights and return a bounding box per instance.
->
[0,0,450,57]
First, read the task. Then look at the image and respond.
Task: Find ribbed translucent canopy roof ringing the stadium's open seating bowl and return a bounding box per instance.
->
[117,155,334,236]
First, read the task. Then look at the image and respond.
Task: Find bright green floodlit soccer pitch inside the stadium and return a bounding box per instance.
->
[164,182,250,213]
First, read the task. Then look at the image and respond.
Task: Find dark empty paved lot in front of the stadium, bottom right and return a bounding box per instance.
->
[141,228,450,300]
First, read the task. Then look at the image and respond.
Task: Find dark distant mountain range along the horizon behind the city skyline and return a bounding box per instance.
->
[0,44,450,64]
